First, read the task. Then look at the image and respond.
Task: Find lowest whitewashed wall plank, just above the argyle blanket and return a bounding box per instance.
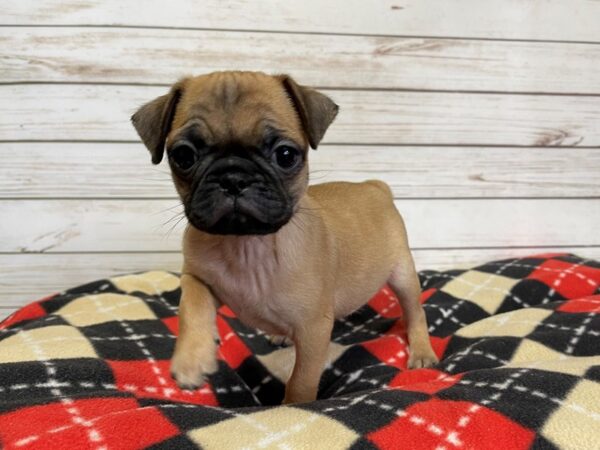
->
[0,247,600,308]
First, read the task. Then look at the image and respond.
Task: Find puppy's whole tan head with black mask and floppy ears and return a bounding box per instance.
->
[132,72,338,235]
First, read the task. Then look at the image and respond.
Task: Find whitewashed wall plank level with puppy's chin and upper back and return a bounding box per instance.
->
[0,199,600,252]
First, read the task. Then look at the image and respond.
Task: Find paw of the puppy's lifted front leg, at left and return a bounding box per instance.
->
[171,340,218,390]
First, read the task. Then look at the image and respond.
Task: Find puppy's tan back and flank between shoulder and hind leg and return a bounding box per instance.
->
[308,180,409,317]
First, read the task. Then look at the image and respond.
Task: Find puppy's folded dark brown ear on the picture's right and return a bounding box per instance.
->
[280,75,339,149]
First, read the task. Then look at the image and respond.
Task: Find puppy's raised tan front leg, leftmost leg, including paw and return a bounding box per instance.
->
[171,273,217,389]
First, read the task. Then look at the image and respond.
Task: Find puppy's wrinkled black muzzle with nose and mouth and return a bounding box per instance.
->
[185,157,293,235]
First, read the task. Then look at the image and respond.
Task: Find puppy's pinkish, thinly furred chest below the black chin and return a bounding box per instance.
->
[189,237,285,333]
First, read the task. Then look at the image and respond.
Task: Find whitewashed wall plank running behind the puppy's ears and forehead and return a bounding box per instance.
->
[0,85,600,146]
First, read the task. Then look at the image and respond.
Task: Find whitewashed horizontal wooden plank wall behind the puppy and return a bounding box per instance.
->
[0,0,600,316]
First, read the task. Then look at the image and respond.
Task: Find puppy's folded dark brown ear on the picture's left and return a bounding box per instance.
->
[131,80,185,164]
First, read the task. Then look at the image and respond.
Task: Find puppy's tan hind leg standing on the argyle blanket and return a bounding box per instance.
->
[388,250,438,369]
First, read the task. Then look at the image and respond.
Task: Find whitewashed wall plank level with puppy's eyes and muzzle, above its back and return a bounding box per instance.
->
[0,142,600,198]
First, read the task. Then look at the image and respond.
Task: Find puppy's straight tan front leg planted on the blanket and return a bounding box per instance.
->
[283,312,333,403]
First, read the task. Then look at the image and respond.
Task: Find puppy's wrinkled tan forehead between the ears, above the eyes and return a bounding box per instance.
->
[169,72,306,146]
